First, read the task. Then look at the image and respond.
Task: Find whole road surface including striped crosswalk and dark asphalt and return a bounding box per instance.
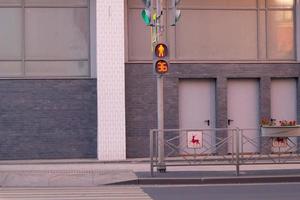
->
[0,183,300,200]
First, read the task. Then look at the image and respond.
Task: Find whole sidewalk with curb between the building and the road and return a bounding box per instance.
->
[0,159,300,187]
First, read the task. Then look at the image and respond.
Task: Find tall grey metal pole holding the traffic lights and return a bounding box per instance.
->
[155,0,166,172]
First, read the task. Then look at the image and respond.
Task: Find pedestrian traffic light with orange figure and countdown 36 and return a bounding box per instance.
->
[153,43,169,74]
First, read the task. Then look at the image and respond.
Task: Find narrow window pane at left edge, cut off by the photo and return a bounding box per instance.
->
[0,8,22,60]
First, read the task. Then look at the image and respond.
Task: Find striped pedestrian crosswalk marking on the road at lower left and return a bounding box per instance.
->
[0,186,151,200]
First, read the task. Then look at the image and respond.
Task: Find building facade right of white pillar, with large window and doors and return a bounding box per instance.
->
[125,0,300,157]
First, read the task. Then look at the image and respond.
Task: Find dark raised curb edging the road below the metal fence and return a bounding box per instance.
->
[108,176,300,185]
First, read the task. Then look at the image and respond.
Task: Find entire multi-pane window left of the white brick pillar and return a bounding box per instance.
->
[0,0,90,78]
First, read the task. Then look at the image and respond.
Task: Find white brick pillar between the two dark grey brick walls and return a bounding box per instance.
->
[97,0,126,160]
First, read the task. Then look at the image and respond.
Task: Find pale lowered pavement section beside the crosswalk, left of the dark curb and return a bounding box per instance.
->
[0,170,137,187]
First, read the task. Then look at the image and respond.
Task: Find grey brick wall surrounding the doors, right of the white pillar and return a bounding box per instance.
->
[126,63,300,157]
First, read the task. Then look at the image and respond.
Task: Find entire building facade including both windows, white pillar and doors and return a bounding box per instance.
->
[0,0,300,160]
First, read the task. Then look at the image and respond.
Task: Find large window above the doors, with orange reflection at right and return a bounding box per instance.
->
[128,0,295,61]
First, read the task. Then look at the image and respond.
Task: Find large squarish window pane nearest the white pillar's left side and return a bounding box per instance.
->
[25,8,89,60]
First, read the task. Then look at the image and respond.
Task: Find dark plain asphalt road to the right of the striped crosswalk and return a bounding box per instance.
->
[142,183,300,200]
